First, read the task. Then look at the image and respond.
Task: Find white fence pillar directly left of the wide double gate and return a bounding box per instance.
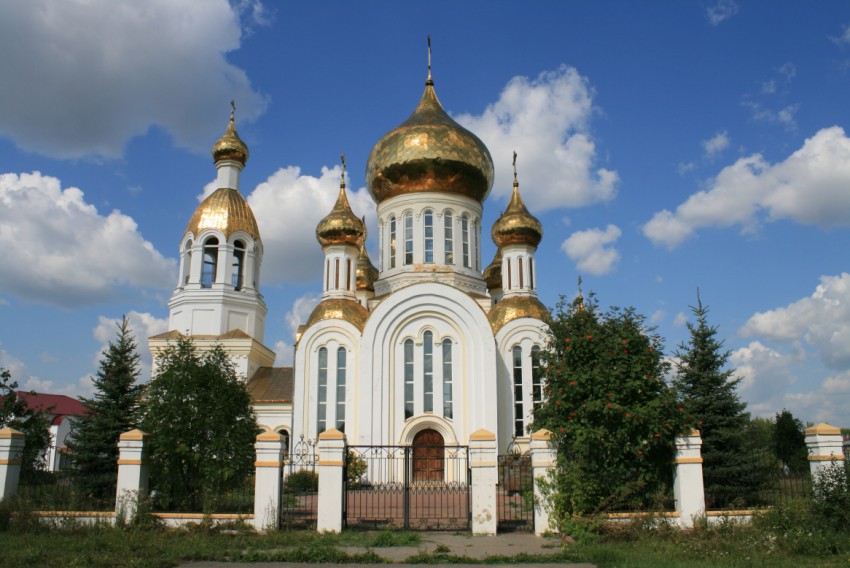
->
[316,428,345,532]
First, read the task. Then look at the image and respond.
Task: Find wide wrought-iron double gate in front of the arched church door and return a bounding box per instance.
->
[343,444,471,531]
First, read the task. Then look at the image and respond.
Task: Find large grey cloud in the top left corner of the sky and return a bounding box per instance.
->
[0,0,267,158]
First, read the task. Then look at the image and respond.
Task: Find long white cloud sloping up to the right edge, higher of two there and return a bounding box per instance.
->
[643,126,850,249]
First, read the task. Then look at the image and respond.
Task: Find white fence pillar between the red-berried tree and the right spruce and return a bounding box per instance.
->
[673,430,705,528]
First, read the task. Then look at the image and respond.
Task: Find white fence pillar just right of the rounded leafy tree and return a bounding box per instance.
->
[254,432,283,531]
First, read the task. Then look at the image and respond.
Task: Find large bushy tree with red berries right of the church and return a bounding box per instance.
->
[533,296,690,516]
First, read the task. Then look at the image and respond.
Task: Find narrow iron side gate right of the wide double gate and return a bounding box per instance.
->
[496,446,534,532]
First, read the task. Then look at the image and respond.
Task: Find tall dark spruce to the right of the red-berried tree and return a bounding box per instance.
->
[675,291,763,507]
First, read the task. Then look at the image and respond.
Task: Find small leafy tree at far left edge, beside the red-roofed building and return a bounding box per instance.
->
[0,368,50,473]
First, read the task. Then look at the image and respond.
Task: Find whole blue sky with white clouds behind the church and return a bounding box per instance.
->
[0,0,850,426]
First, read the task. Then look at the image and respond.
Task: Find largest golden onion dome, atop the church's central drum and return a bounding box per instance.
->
[366,79,493,203]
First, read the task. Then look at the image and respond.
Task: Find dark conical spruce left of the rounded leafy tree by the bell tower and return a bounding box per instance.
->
[68,317,141,496]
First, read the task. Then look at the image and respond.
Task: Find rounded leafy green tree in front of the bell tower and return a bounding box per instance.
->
[141,337,257,509]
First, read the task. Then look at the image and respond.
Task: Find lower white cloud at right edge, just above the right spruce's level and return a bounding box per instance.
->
[739,272,850,370]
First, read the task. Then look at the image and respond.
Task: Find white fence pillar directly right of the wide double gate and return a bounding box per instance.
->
[469,428,499,535]
